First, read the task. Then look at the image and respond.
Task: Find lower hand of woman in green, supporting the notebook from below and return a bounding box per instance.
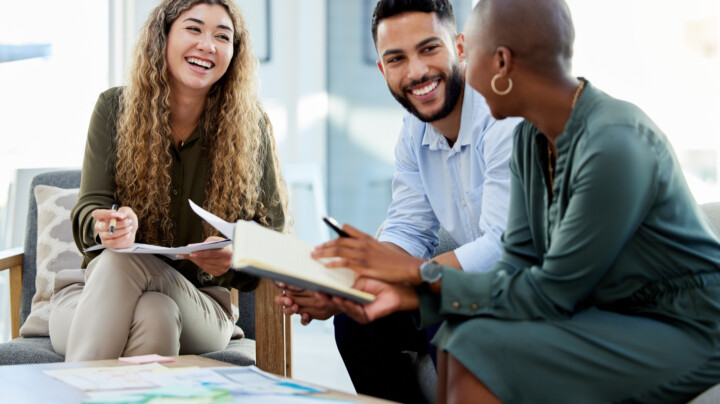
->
[316,278,420,324]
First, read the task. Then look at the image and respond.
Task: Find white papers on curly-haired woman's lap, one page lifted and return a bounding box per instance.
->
[83,199,235,259]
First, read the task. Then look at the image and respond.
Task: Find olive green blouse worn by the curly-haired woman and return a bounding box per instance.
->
[71,87,285,291]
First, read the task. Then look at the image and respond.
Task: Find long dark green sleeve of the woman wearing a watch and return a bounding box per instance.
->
[428,126,658,320]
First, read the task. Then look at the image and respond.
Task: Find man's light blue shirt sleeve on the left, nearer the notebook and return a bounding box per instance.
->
[378,117,440,259]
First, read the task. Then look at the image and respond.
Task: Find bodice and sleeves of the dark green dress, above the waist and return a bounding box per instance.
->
[420,79,720,325]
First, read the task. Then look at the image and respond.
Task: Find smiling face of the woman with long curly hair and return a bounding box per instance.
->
[166,4,233,94]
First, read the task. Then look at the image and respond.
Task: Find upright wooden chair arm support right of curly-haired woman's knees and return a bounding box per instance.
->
[255,279,292,377]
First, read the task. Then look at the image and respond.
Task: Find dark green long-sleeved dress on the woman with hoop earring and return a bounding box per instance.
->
[420,79,720,403]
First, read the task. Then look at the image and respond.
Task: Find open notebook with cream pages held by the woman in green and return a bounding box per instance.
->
[232,220,375,303]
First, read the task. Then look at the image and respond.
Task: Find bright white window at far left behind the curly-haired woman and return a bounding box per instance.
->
[0,0,108,341]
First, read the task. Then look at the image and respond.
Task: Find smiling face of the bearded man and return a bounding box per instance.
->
[375,12,463,122]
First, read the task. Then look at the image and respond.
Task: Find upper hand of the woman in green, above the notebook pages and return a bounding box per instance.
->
[312,224,424,285]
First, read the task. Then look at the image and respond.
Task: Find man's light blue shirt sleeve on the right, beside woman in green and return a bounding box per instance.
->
[455,119,518,272]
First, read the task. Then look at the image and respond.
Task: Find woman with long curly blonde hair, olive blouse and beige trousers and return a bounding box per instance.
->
[50,0,287,361]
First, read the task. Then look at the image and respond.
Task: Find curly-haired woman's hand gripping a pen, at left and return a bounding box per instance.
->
[92,206,138,249]
